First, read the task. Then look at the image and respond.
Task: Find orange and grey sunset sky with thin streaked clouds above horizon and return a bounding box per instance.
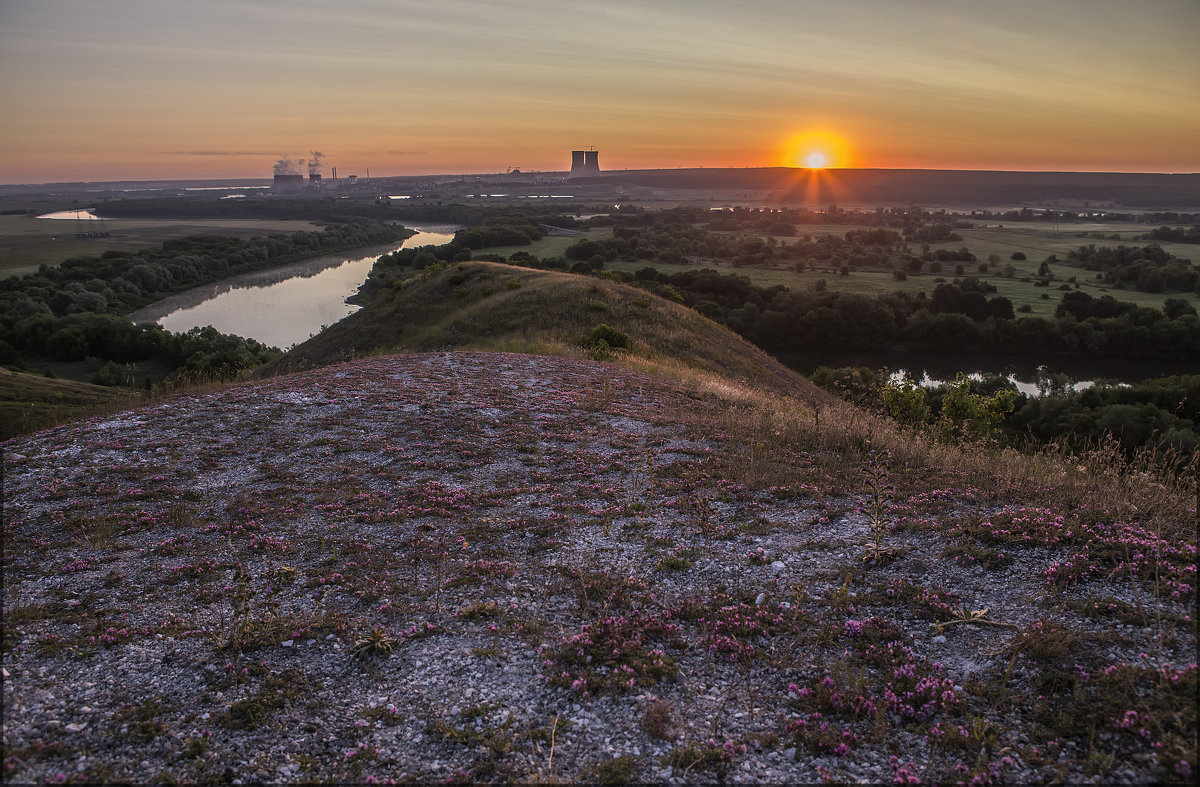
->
[0,0,1200,184]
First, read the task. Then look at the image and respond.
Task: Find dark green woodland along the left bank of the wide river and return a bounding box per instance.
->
[0,221,413,385]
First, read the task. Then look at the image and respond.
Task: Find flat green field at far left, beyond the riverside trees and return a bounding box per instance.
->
[0,215,316,276]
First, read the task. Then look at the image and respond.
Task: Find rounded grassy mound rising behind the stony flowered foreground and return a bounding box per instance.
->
[259,262,823,399]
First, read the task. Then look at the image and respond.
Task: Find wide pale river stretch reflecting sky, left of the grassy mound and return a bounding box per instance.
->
[131,226,456,348]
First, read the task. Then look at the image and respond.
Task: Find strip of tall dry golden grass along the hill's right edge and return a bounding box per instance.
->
[662,364,1200,537]
